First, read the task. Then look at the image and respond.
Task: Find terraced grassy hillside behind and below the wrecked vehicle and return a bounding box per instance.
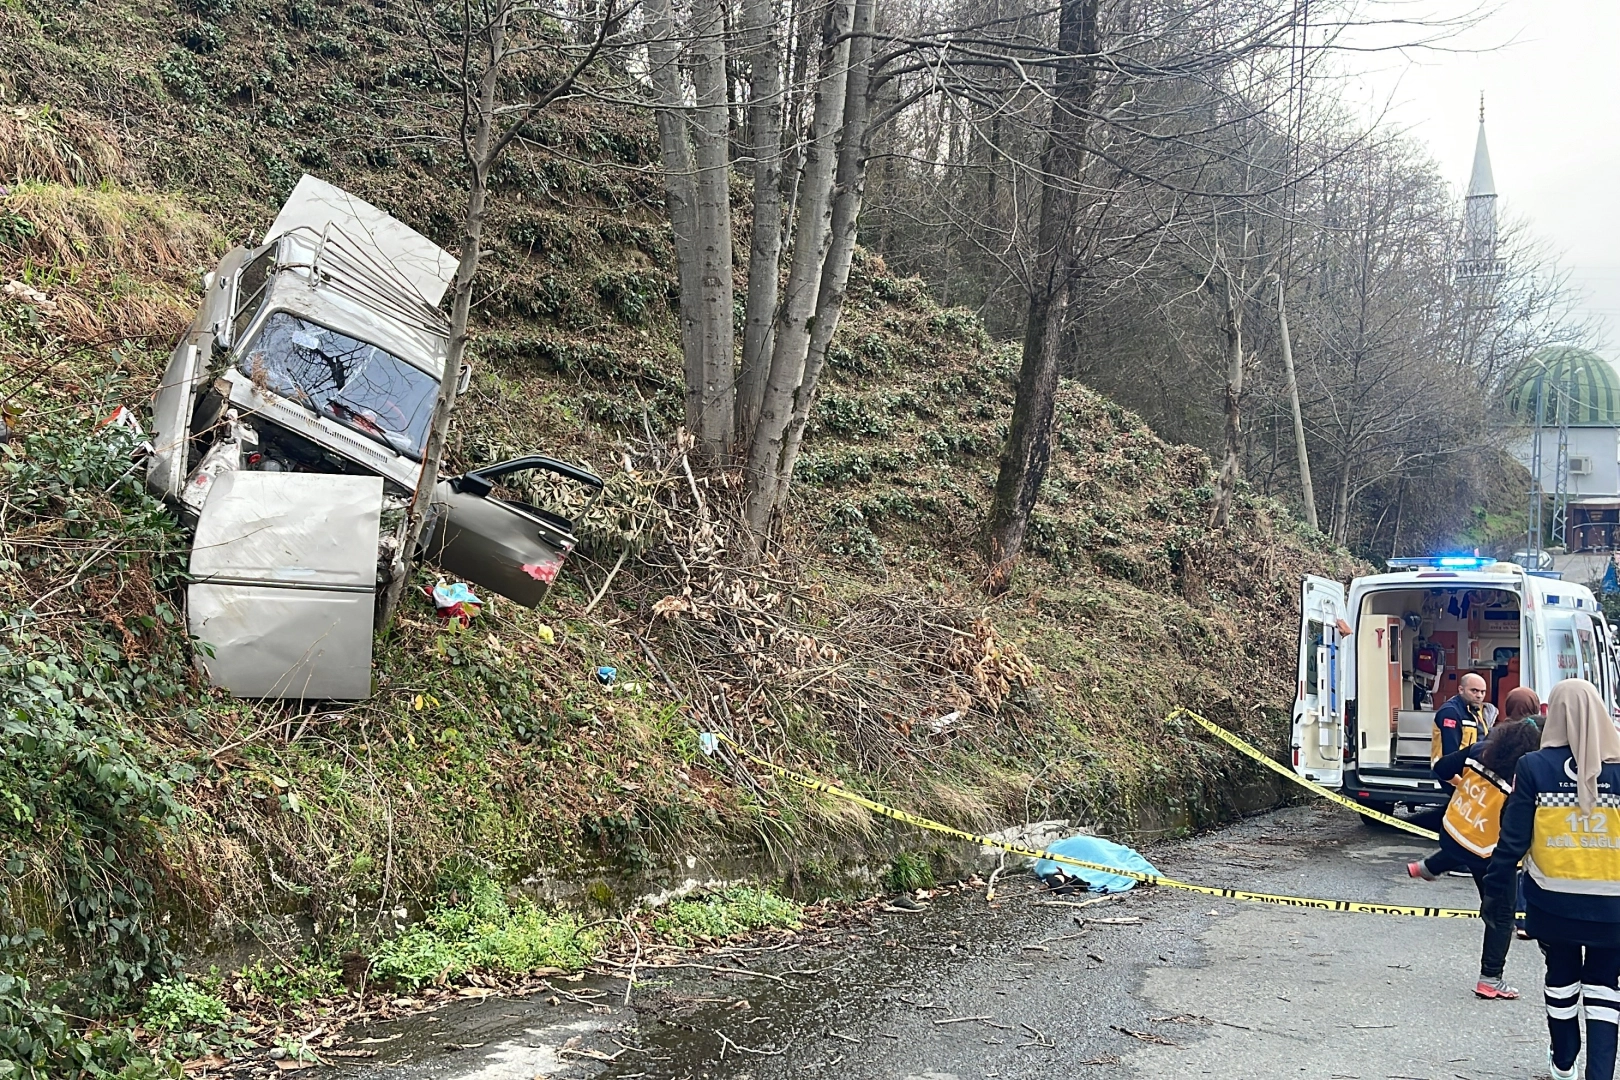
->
[0,0,1348,958]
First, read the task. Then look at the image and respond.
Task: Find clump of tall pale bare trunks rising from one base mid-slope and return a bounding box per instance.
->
[648,0,875,546]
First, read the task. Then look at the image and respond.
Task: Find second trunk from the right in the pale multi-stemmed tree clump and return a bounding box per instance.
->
[745,0,854,546]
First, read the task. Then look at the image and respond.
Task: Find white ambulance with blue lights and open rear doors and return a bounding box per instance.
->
[1293,555,1617,813]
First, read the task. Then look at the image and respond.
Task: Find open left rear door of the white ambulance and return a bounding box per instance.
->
[1293,575,1351,787]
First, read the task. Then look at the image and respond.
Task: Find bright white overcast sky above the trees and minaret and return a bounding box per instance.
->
[1351,0,1620,351]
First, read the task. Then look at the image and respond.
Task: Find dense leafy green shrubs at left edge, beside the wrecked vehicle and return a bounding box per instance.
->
[0,419,191,994]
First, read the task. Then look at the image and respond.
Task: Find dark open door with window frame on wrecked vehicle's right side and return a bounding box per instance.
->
[424,457,603,607]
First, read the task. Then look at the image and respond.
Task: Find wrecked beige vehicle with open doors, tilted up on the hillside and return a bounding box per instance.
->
[146,176,603,699]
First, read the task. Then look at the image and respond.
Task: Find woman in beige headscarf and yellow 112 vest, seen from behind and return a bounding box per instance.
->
[1486,678,1620,1080]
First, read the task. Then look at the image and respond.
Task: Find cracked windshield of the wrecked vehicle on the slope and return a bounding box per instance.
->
[237,311,439,461]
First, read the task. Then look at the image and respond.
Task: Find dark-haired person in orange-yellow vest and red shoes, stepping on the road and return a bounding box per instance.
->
[1406,721,1541,999]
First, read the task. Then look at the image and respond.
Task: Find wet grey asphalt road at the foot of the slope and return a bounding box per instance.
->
[348,806,1545,1080]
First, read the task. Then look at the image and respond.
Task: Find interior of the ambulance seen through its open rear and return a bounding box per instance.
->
[1356,586,1520,772]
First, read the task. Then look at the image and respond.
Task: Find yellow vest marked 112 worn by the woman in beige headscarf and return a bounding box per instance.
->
[1524,758,1620,897]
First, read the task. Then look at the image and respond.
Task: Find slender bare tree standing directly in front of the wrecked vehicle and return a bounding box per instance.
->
[382,0,616,627]
